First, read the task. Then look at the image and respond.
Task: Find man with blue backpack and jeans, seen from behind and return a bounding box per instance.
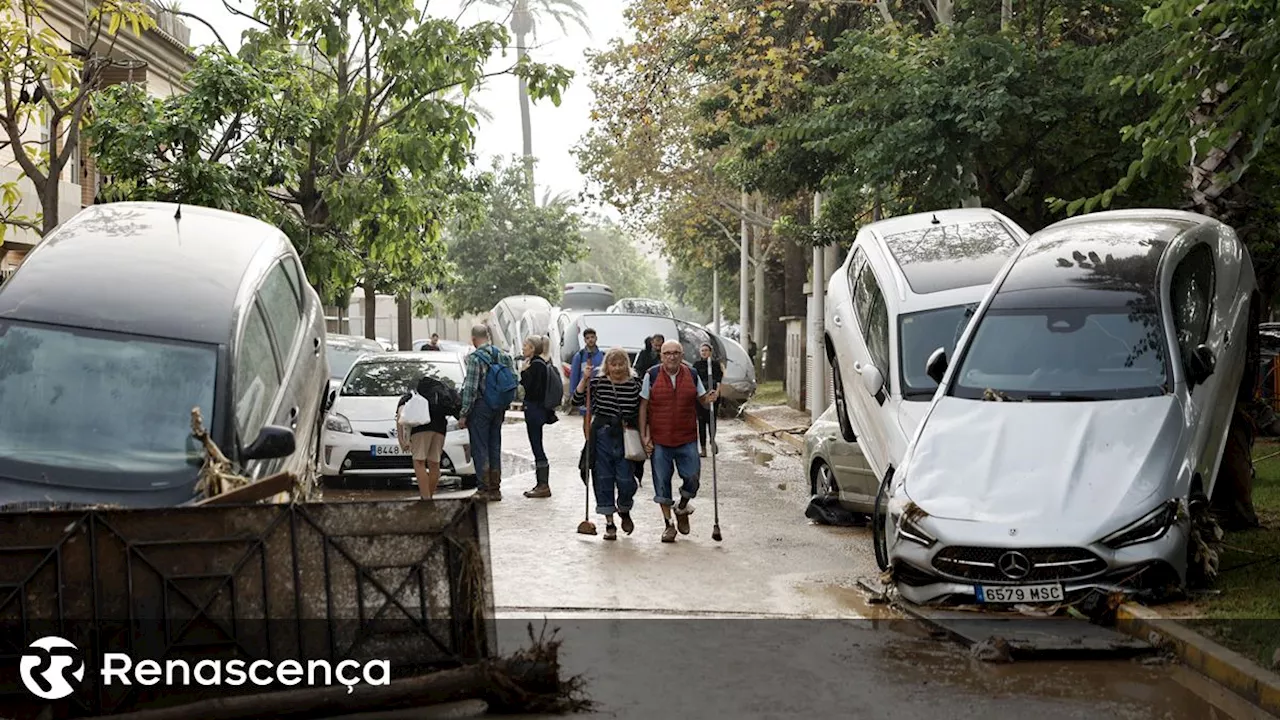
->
[458,324,518,502]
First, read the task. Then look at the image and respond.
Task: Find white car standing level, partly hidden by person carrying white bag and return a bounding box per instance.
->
[320,351,475,487]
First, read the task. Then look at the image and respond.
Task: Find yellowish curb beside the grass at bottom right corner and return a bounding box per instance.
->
[1116,602,1280,716]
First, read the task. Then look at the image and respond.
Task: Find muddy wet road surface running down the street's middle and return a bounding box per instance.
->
[317,416,1266,720]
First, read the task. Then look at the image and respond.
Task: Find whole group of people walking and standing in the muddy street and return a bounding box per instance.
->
[401,324,723,542]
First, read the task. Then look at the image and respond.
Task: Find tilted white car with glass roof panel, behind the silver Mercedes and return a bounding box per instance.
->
[824,209,1027,478]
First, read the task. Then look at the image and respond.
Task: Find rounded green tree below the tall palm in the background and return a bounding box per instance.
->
[444,158,588,315]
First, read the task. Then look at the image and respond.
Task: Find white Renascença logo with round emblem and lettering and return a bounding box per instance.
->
[20,635,392,700]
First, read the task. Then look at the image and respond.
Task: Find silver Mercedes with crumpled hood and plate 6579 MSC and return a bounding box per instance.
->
[874,210,1260,605]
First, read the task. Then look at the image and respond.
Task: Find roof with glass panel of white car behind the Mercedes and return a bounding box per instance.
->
[859,208,1027,297]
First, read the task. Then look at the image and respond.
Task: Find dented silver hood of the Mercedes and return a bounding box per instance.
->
[905,395,1183,533]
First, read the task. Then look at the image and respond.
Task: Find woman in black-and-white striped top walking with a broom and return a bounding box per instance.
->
[572,347,640,541]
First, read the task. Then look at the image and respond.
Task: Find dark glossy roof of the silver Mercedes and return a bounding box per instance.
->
[1000,210,1212,293]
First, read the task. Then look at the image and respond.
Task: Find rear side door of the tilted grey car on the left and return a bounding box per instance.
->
[259,255,323,477]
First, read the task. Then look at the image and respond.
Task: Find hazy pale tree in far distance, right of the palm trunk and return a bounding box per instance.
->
[561,218,666,300]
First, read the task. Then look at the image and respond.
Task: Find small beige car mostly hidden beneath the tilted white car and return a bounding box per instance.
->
[804,405,879,516]
